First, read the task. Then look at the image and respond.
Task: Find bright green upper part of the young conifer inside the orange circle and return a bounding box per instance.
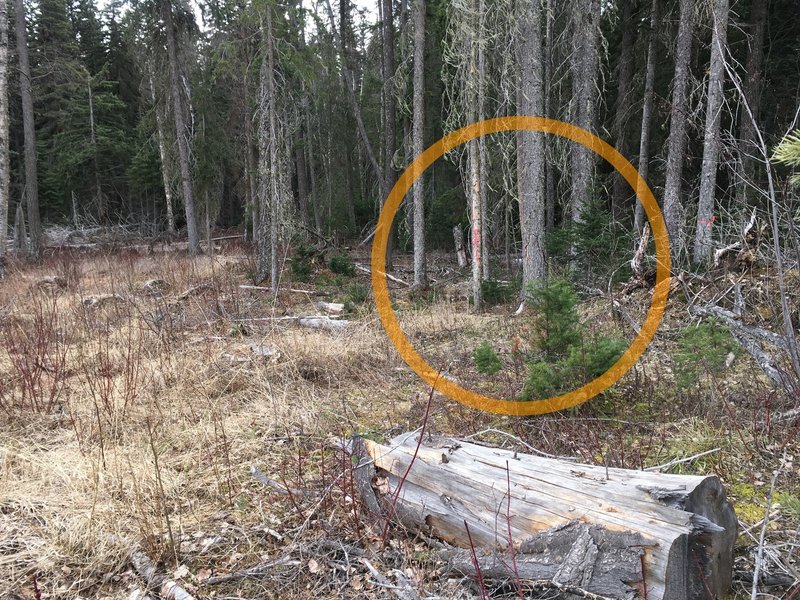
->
[526,278,581,360]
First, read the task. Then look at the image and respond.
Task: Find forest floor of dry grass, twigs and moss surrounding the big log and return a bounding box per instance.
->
[0,237,800,600]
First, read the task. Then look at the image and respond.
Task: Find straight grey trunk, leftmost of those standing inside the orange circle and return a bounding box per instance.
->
[411,0,428,287]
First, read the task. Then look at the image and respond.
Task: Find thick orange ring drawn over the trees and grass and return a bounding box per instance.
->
[371,116,670,416]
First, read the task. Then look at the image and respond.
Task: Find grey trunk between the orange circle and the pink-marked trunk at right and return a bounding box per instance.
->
[664,0,695,264]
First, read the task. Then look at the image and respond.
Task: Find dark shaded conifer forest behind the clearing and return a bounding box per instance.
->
[0,0,800,286]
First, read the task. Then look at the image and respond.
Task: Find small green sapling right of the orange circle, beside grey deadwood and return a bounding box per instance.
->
[673,319,738,389]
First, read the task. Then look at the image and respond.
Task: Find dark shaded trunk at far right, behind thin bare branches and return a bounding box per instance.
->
[736,0,769,215]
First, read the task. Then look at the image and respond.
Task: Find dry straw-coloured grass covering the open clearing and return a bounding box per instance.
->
[0,246,797,599]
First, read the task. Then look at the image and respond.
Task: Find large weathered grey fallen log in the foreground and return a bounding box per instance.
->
[353,433,737,600]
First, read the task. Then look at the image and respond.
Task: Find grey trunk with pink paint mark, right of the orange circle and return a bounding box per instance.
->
[693,0,728,263]
